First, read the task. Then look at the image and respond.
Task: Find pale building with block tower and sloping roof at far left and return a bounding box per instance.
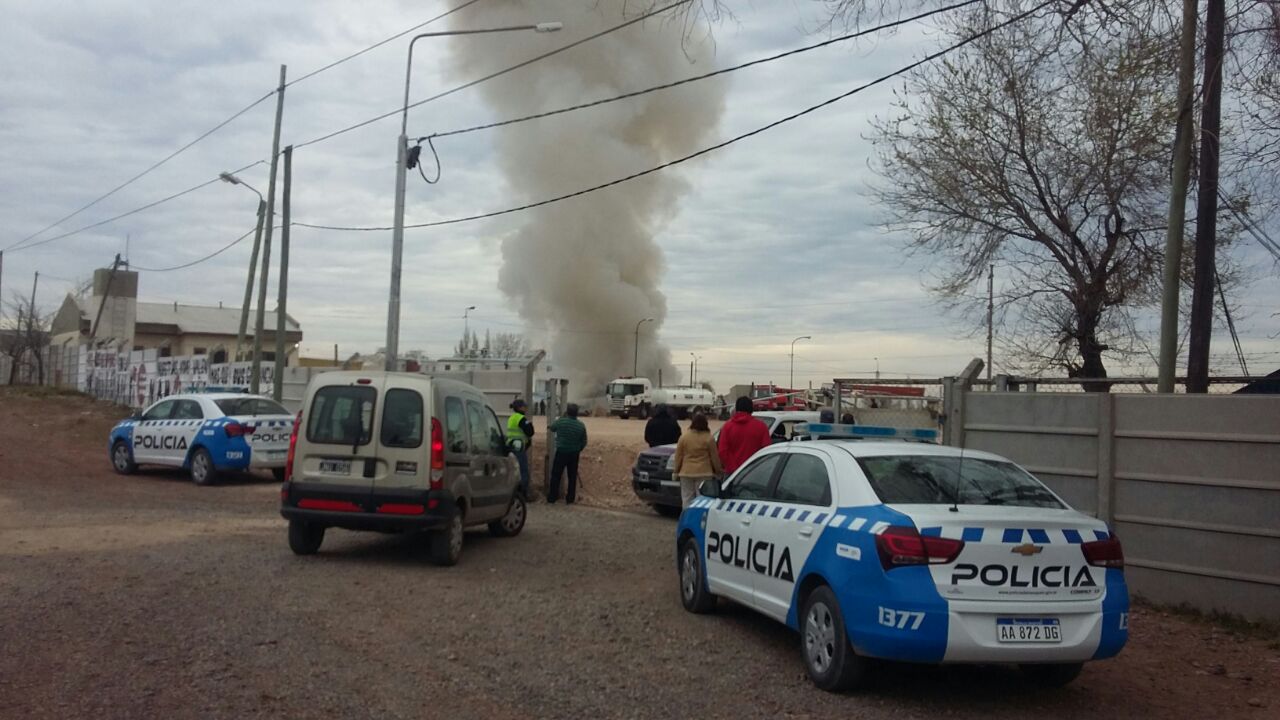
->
[50,269,302,365]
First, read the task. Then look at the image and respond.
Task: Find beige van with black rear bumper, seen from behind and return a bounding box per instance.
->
[280,370,526,565]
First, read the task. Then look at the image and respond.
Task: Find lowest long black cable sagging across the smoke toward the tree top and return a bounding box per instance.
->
[294,0,1055,232]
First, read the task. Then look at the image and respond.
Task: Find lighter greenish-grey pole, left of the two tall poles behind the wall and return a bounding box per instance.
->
[1157,0,1198,392]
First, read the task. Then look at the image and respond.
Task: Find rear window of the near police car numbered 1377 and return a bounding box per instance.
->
[858,455,1064,509]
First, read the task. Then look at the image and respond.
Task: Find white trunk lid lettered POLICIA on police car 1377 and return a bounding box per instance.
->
[888,505,1107,602]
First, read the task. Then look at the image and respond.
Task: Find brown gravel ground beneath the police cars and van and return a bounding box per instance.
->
[0,388,1280,720]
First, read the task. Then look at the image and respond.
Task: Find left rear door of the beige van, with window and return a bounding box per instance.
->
[293,378,384,503]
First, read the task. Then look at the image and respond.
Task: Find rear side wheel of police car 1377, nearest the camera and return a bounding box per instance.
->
[800,585,867,692]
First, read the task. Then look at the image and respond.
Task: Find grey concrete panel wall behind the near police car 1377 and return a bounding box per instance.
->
[960,392,1280,621]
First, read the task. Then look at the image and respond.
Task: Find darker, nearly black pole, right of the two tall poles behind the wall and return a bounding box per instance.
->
[1187,0,1226,393]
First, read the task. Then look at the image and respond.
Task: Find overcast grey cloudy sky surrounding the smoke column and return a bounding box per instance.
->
[0,0,1280,387]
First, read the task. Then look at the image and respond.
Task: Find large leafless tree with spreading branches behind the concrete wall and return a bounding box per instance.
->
[873,5,1230,391]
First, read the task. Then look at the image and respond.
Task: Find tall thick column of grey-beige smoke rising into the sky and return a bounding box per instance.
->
[449,0,724,397]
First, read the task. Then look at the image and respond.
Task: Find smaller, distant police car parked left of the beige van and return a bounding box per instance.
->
[108,393,293,486]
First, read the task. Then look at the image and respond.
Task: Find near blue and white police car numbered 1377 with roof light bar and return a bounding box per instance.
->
[676,423,1129,691]
